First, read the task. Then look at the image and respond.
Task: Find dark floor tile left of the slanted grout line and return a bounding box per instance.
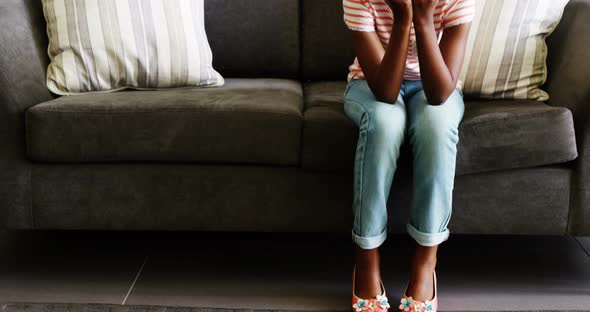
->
[0,233,144,303]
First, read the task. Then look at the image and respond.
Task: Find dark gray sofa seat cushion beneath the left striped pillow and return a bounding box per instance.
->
[26,79,303,165]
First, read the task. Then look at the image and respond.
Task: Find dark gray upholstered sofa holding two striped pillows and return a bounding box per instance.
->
[0,0,590,235]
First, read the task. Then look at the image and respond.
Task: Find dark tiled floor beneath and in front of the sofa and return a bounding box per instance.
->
[0,231,590,311]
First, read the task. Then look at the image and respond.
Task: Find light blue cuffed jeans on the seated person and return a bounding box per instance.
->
[344,79,465,249]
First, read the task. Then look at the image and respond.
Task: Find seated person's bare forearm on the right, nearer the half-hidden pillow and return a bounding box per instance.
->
[414,19,456,105]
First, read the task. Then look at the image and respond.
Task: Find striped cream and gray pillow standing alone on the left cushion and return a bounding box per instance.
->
[43,0,224,95]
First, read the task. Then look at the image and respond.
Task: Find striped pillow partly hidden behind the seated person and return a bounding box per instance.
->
[460,0,568,101]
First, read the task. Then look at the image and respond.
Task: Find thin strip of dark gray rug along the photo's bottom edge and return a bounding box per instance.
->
[0,303,588,312]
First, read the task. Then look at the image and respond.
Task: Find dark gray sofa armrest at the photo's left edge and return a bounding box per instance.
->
[0,0,53,229]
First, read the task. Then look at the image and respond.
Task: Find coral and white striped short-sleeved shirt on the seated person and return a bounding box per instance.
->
[343,0,475,86]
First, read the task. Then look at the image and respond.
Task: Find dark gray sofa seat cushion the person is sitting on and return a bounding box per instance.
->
[302,81,577,175]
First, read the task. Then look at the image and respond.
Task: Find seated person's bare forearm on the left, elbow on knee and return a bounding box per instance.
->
[368,23,410,103]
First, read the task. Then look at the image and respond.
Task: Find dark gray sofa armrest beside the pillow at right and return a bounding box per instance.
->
[545,0,590,235]
